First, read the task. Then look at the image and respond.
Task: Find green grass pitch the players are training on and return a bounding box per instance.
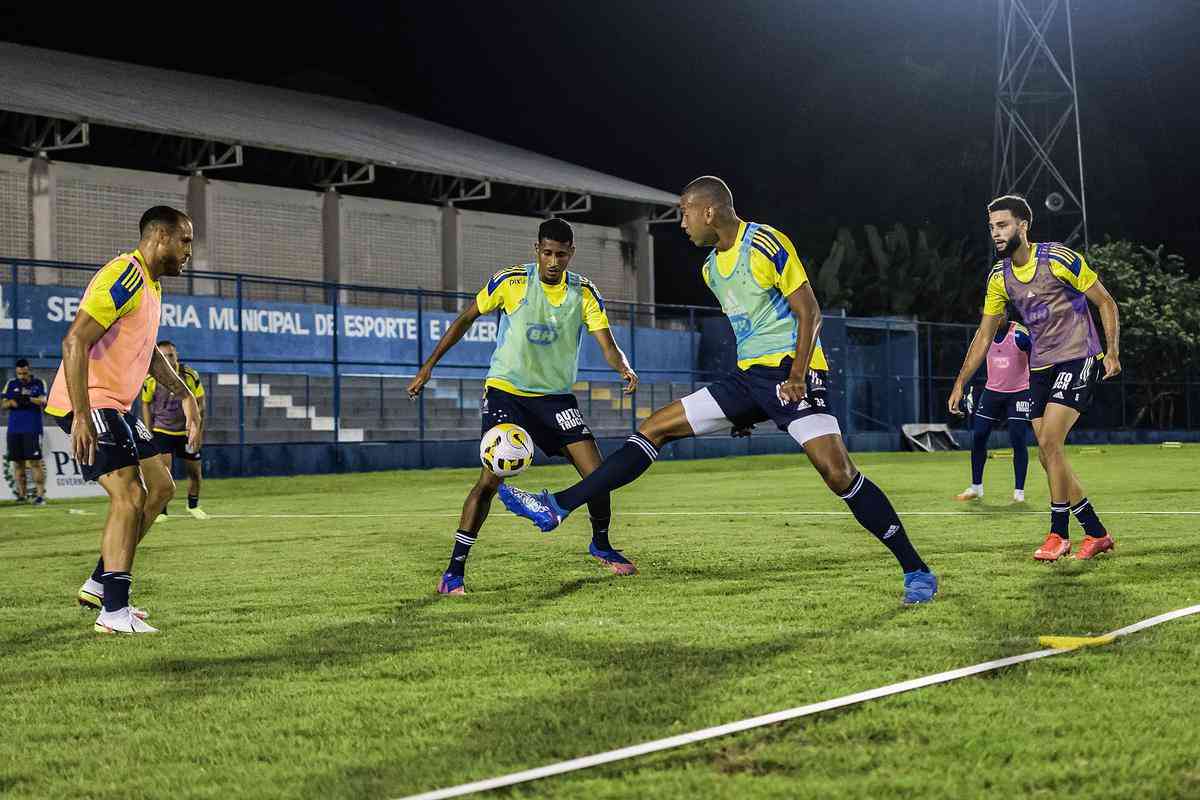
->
[0,446,1200,800]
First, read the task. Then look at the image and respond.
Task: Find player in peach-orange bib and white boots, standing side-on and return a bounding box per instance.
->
[46,205,200,633]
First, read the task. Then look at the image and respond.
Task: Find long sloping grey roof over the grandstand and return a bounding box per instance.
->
[0,43,677,210]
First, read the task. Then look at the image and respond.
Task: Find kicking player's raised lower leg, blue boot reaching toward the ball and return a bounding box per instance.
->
[500,401,692,533]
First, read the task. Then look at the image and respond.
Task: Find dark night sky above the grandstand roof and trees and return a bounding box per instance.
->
[0,0,1200,303]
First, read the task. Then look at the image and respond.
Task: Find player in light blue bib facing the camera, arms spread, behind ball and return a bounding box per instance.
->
[408,218,637,595]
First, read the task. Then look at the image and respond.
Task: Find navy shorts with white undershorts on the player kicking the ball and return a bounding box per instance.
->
[683,357,841,444]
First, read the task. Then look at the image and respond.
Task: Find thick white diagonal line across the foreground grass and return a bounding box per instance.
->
[401,606,1200,800]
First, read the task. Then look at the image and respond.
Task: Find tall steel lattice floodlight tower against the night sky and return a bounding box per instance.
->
[992,0,1088,249]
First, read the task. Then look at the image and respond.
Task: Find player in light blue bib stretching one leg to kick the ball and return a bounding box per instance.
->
[499,175,937,604]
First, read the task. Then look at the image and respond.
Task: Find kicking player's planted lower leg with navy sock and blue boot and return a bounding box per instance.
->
[803,433,937,606]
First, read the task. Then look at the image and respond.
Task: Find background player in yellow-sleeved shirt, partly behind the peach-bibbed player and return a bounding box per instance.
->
[142,339,209,519]
